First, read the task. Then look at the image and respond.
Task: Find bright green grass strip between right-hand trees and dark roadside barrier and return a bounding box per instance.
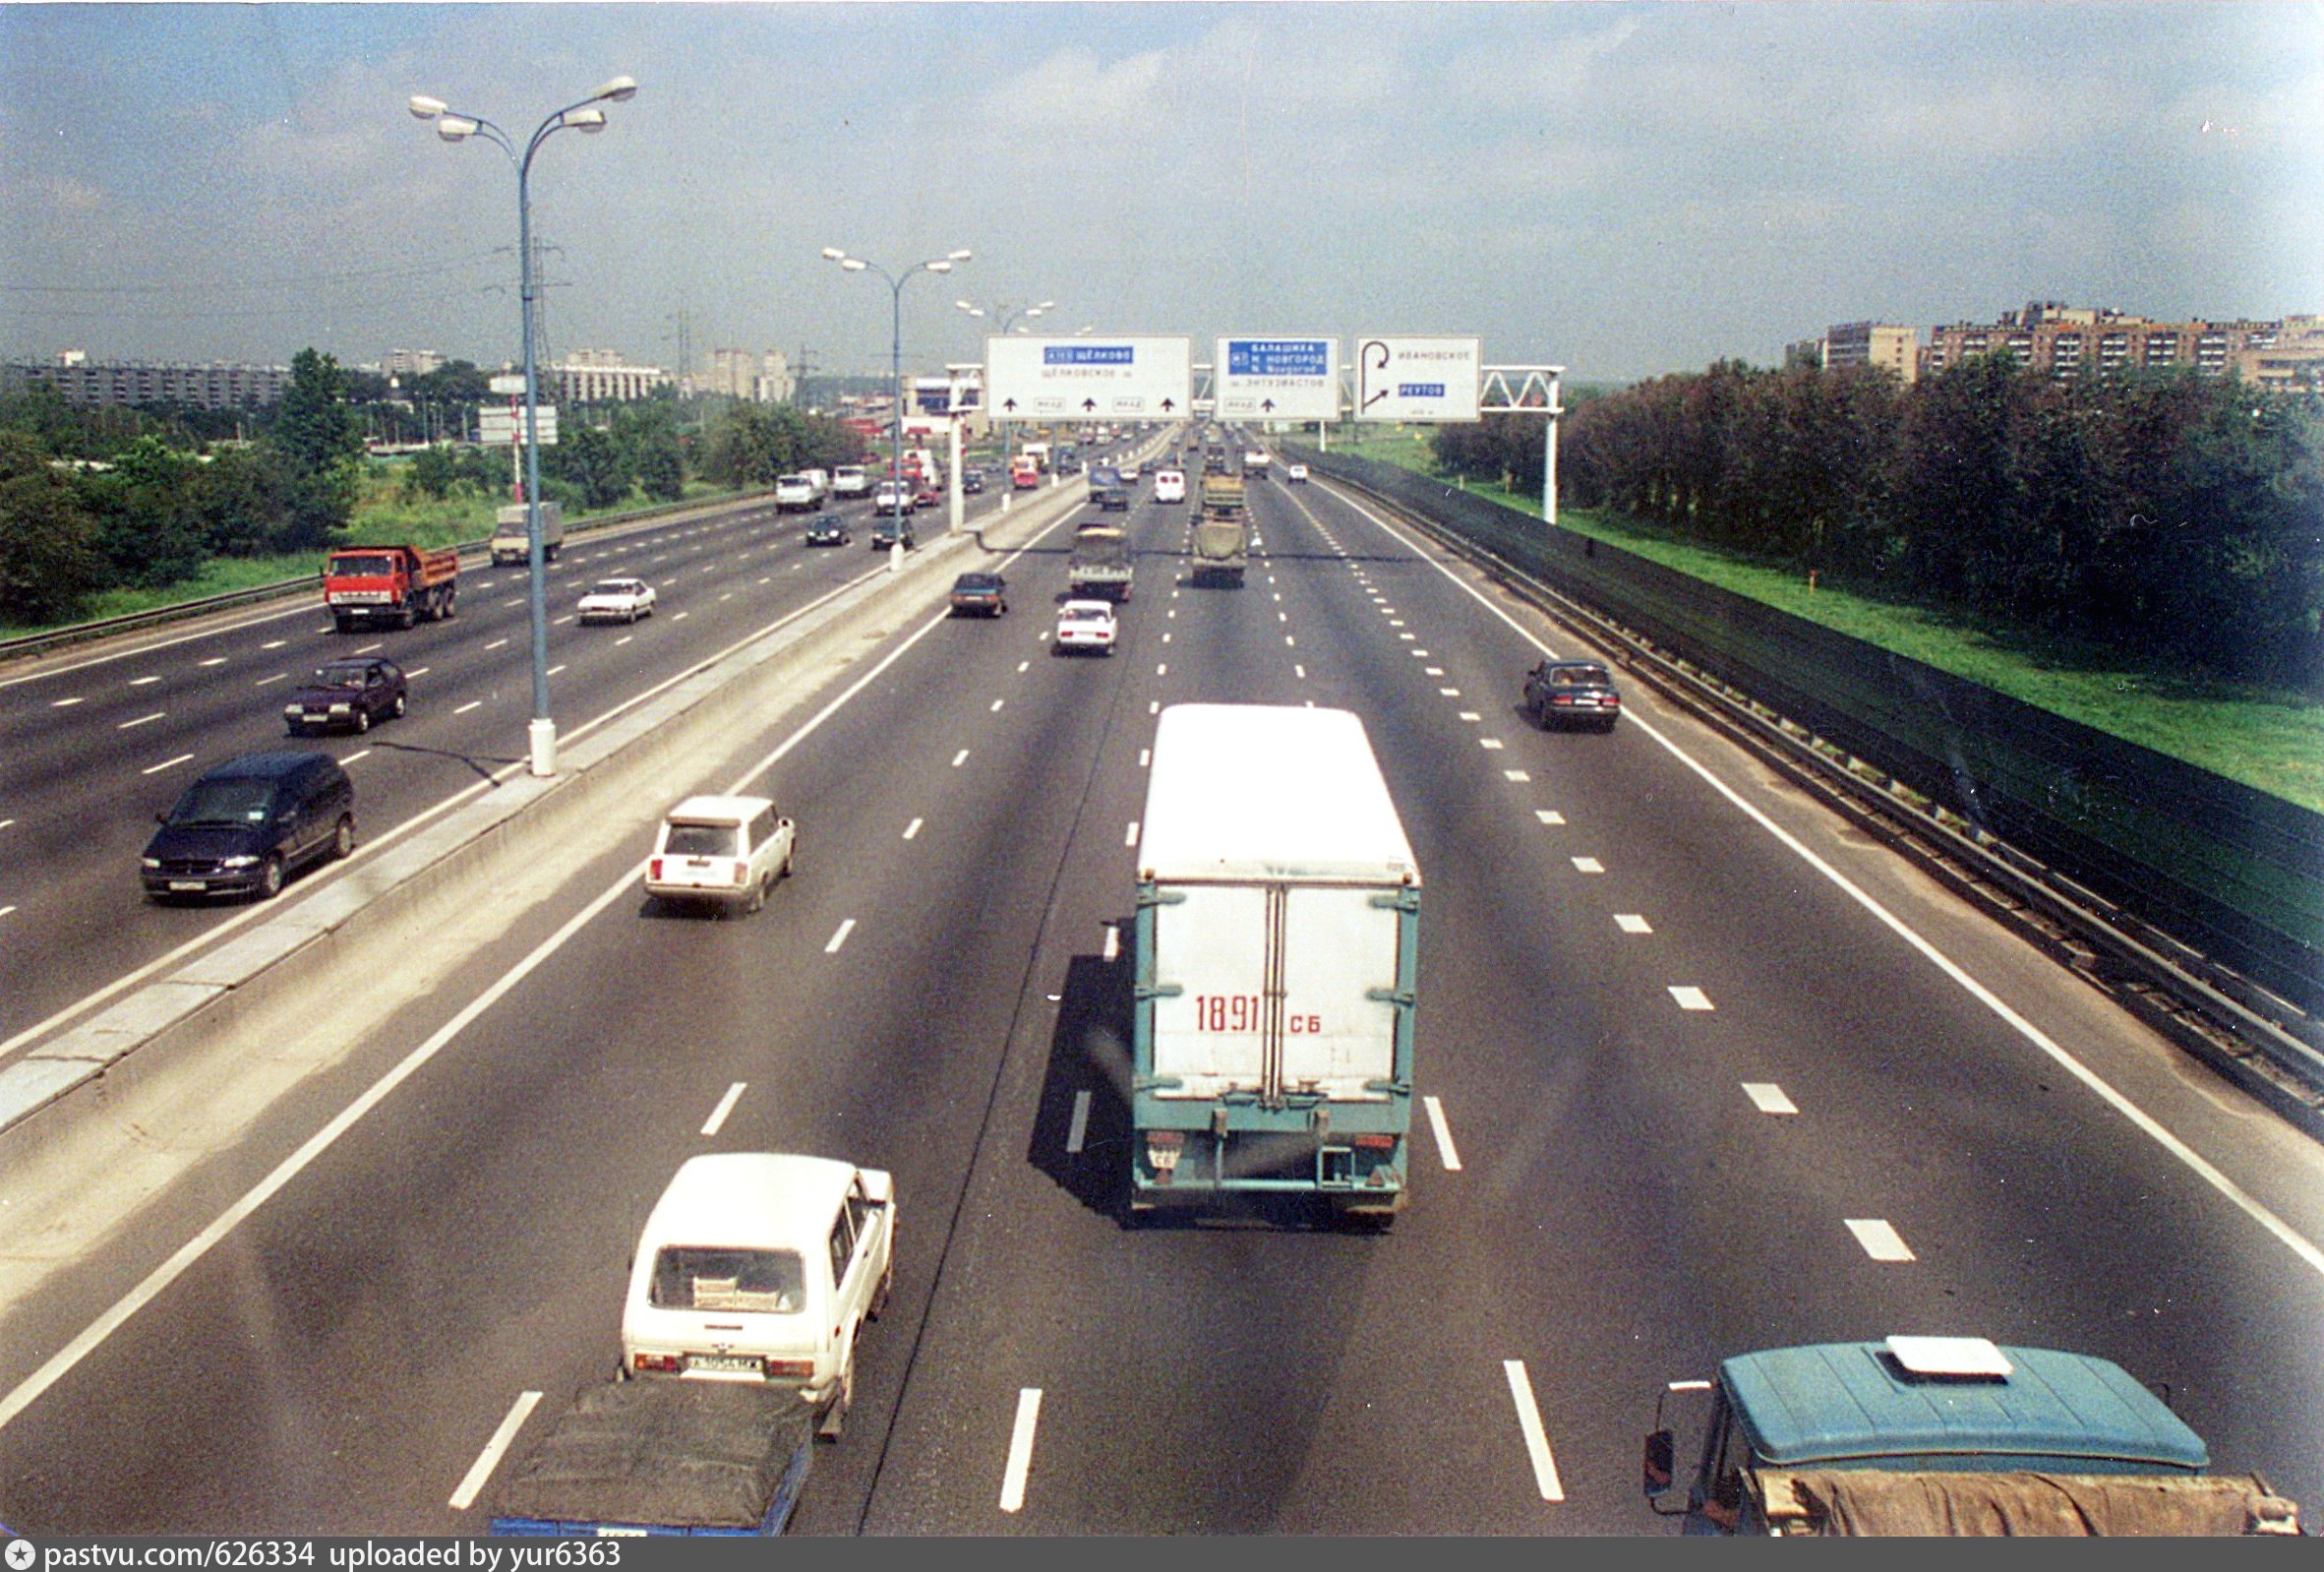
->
[1332,428,2324,812]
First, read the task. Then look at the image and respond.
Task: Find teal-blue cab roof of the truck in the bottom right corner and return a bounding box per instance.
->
[1720,1342,2210,1472]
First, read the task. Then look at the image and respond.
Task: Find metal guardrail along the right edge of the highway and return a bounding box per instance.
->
[1308,442,2324,1135]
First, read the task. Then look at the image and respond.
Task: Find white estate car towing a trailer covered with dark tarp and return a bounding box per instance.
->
[621,1151,895,1435]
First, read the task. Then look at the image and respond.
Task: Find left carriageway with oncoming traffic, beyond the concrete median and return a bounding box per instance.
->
[0,481,1022,1051]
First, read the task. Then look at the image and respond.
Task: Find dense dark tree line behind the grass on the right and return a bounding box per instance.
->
[1436,356,2324,689]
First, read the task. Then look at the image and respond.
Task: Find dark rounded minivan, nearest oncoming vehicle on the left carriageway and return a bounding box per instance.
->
[137,754,356,900]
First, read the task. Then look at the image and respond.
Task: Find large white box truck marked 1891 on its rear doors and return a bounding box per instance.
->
[1129,704,1420,1221]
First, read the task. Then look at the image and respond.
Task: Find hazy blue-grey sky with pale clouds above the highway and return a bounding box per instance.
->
[0,0,2324,382]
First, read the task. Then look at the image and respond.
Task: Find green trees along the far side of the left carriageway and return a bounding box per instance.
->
[0,349,863,626]
